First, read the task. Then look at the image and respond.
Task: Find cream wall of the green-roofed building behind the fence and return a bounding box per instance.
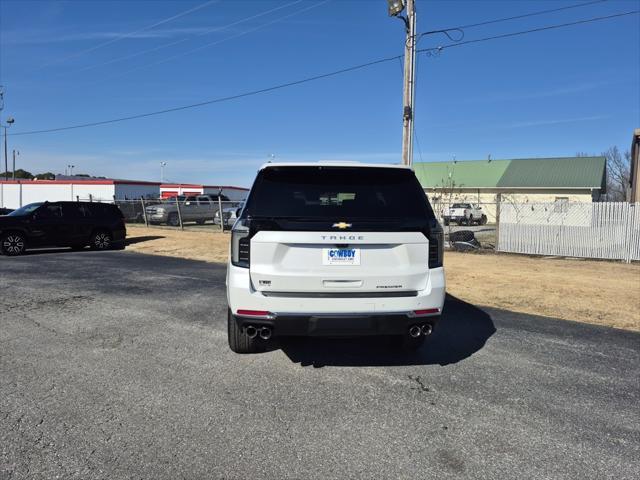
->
[425,189,594,223]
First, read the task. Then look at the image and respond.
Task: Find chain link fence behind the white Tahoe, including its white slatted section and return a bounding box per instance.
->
[79,197,640,262]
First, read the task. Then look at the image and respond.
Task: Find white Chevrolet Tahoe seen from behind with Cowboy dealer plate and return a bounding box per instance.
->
[227,162,445,353]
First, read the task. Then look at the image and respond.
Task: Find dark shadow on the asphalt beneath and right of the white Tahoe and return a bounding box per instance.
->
[279,295,496,368]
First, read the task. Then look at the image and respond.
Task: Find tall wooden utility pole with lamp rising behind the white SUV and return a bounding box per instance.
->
[387,0,417,165]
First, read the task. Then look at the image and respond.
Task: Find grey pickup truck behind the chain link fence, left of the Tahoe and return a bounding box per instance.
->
[145,195,229,227]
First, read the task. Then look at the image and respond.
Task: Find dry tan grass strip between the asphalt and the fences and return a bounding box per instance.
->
[127,226,640,331]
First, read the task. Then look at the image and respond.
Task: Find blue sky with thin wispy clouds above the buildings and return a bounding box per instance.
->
[0,0,640,185]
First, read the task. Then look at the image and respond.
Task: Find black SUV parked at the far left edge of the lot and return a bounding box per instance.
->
[0,202,126,255]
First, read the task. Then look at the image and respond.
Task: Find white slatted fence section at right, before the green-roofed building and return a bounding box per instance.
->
[497,202,640,262]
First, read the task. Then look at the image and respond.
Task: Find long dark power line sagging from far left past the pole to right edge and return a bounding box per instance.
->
[10,10,640,136]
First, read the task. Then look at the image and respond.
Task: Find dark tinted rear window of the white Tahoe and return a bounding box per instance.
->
[245,166,433,219]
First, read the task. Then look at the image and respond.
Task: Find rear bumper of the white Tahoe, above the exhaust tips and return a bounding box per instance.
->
[227,265,445,336]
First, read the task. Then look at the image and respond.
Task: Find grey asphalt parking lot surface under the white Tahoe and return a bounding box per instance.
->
[0,251,640,480]
